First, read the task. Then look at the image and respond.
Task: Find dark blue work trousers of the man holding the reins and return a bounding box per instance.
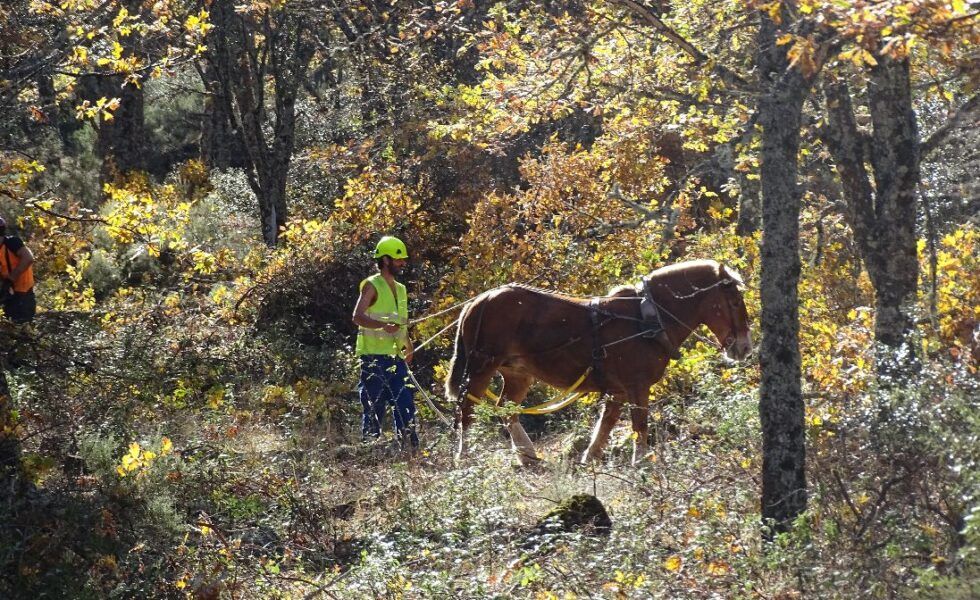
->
[358,354,419,447]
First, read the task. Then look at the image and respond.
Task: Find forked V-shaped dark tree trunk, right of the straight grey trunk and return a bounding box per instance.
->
[821,56,919,378]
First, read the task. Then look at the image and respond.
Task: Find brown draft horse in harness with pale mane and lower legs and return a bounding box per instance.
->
[446,260,752,464]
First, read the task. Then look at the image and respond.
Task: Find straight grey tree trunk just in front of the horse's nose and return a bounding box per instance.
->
[757,16,809,531]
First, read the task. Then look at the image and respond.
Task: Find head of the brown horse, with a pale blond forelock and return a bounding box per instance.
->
[701,265,752,360]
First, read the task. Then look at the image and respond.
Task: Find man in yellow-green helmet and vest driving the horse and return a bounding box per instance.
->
[353,236,419,449]
